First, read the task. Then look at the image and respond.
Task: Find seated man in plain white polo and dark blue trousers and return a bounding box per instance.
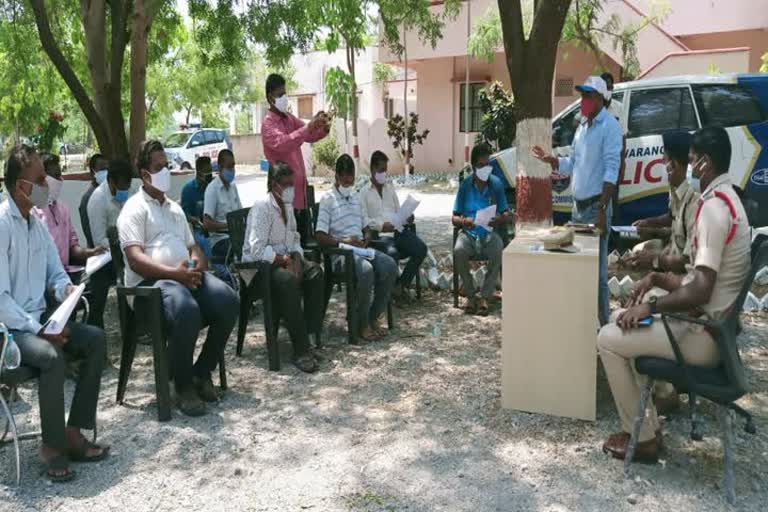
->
[117,140,239,416]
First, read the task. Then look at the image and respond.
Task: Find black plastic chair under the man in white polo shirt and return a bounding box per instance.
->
[107,228,227,421]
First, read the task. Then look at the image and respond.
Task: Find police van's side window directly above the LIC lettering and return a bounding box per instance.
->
[627,87,698,137]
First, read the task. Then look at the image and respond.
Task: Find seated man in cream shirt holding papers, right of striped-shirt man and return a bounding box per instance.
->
[360,151,427,297]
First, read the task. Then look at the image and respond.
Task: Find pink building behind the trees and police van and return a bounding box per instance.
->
[379,0,768,171]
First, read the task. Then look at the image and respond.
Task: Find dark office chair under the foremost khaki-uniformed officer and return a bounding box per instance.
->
[624,235,768,504]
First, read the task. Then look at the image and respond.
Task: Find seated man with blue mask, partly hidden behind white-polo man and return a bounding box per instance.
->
[87,160,133,328]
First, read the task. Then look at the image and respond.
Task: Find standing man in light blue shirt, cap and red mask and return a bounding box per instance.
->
[533,76,622,325]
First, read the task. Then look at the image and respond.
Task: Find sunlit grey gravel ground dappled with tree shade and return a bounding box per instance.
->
[0,208,768,512]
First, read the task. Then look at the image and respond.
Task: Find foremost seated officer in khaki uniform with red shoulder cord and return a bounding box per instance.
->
[597,127,750,462]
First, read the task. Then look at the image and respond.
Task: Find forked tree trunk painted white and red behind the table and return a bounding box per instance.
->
[498,0,571,229]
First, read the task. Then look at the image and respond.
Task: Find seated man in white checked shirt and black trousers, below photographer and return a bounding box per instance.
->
[243,162,325,373]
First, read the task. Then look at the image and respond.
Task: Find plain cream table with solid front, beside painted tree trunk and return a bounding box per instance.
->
[501,233,599,421]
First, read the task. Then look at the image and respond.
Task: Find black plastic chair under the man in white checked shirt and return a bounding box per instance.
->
[227,208,280,372]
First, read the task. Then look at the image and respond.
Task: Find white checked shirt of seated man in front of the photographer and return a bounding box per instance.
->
[243,194,303,263]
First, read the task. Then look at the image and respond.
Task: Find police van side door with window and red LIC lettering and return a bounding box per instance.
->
[617,86,699,224]
